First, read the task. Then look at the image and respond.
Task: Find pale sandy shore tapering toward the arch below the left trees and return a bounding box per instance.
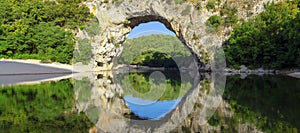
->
[0,59,80,86]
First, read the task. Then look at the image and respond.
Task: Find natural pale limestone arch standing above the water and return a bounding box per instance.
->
[87,0,221,70]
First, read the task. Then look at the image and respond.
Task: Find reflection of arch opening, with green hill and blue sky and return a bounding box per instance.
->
[118,70,192,119]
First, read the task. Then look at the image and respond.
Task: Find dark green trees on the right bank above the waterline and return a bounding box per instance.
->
[225,1,300,69]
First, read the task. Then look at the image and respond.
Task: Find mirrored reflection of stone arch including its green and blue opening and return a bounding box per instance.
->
[74,71,225,132]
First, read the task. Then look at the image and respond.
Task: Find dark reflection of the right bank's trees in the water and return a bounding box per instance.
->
[220,75,300,132]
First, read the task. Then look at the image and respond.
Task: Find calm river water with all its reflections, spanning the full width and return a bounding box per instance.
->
[0,71,300,132]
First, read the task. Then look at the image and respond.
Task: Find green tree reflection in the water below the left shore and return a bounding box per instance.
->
[0,80,92,132]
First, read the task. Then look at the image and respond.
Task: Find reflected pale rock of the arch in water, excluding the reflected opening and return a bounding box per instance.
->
[74,71,226,132]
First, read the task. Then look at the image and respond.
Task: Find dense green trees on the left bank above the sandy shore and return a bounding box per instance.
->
[0,0,90,63]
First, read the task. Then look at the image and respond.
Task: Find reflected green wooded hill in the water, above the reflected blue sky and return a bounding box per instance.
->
[116,70,193,101]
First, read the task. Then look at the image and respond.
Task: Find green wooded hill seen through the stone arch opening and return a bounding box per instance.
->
[118,35,191,67]
